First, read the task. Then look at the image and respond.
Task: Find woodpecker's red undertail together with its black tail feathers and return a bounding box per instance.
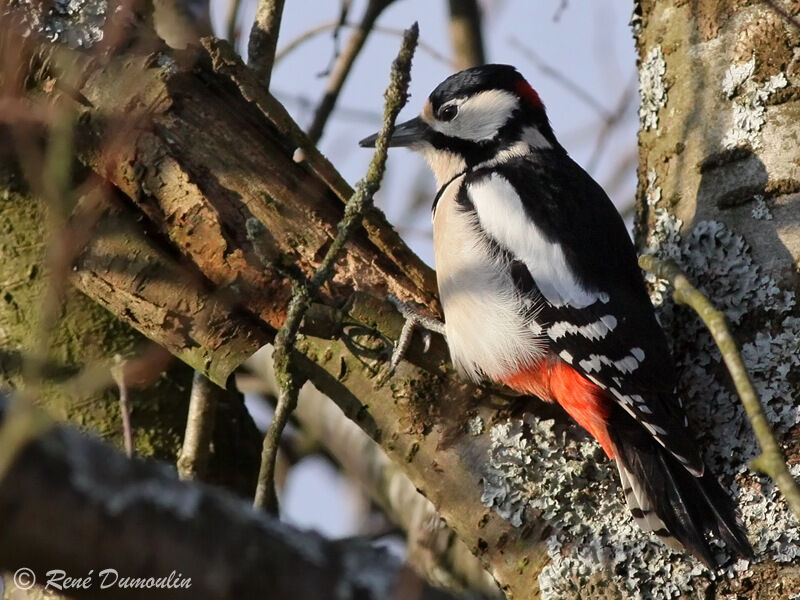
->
[503,356,753,569]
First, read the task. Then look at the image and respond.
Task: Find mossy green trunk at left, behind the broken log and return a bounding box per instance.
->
[0,160,261,496]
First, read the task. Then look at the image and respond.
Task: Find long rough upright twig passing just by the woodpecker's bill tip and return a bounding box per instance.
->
[253,23,419,513]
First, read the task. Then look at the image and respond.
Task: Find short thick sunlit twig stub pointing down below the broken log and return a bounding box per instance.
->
[178,371,219,479]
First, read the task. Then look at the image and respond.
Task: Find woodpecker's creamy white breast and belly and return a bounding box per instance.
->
[433,176,546,380]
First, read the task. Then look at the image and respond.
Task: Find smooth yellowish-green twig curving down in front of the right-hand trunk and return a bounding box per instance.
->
[639,254,800,520]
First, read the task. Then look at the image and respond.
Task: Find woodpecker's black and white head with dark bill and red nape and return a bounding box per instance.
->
[360,65,561,185]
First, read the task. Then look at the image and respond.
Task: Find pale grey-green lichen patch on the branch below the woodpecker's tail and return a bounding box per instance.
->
[482,418,705,600]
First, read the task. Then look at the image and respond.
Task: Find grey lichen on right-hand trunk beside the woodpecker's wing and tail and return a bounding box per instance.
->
[650,217,800,562]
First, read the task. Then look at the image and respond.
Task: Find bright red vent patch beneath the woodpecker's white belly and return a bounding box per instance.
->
[503,359,614,458]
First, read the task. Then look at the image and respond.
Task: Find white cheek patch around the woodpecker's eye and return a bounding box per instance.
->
[430,90,519,142]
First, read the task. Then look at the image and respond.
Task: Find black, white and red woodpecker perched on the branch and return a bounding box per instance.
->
[361,65,752,568]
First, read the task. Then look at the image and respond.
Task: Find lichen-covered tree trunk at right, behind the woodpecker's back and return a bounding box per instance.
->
[634,0,800,599]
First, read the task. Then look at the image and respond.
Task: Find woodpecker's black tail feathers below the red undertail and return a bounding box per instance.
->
[609,408,753,570]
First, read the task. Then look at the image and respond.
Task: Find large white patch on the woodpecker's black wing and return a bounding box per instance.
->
[468,173,608,308]
